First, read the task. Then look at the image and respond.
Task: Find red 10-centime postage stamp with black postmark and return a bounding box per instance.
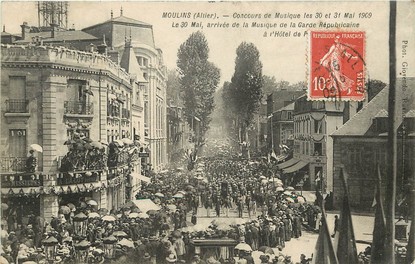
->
[308,31,365,101]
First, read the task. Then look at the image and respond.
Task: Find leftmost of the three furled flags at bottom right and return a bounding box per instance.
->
[311,203,339,264]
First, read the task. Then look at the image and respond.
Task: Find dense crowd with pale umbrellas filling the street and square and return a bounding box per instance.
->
[1,152,321,263]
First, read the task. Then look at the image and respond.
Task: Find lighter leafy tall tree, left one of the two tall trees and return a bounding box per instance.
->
[177,31,220,143]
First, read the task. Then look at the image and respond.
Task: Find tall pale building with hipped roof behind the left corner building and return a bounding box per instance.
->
[82,11,168,171]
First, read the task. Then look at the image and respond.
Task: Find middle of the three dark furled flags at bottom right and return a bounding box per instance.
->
[336,168,358,264]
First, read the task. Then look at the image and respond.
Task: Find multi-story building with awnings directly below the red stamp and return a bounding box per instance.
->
[278,95,354,193]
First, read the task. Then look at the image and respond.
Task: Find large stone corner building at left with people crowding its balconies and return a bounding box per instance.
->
[0,43,140,222]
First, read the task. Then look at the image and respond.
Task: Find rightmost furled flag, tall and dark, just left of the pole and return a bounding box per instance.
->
[370,165,386,264]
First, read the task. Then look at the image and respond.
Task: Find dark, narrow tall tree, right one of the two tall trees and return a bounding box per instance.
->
[229,42,264,157]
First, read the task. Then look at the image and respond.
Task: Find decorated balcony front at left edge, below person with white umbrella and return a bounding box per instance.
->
[1,173,43,188]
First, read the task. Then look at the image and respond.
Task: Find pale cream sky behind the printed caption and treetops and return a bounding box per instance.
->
[1,1,415,83]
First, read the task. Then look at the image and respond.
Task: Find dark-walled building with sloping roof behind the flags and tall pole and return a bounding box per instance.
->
[331,78,415,210]
